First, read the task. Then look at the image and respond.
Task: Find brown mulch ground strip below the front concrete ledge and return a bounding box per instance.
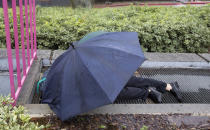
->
[32,114,210,130]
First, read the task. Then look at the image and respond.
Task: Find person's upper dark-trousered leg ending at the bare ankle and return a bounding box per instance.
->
[126,76,169,93]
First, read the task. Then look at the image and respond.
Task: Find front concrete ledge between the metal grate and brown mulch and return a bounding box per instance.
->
[24,104,210,117]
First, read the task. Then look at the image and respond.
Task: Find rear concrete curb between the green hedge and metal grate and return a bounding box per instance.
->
[0,48,210,71]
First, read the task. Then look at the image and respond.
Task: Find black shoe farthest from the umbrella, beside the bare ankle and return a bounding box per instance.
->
[170,82,182,103]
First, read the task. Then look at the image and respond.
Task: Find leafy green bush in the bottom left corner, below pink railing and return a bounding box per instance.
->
[0,96,45,130]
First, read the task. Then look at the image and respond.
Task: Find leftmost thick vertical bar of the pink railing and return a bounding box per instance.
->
[2,0,15,99]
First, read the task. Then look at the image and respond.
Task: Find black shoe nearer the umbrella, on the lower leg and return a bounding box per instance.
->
[148,87,162,103]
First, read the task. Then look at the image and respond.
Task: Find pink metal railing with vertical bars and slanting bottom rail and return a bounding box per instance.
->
[2,0,37,101]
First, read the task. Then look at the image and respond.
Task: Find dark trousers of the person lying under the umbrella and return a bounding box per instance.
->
[117,76,167,100]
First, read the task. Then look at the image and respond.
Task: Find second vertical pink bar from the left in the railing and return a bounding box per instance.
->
[12,0,21,92]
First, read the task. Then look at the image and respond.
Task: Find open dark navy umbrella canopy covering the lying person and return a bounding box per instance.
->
[42,32,145,121]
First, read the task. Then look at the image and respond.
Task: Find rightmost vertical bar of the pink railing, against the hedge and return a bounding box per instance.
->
[33,0,37,58]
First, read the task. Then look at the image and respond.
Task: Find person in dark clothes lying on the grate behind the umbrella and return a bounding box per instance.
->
[37,69,182,103]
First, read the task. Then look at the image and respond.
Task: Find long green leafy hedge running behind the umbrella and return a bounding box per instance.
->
[0,5,210,52]
